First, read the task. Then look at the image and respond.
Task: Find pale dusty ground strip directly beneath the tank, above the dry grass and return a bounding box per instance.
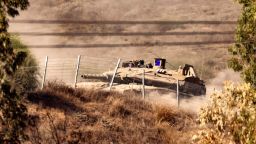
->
[77,82,208,113]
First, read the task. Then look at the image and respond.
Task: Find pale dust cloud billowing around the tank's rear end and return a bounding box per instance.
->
[148,69,242,113]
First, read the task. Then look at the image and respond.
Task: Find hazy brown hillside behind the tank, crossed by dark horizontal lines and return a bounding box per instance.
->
[10,0,239,78]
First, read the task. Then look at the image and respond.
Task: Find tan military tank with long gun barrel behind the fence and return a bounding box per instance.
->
[81,58,206,95]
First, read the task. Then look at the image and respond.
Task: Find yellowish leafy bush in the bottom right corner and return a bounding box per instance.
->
[195,83,256,144]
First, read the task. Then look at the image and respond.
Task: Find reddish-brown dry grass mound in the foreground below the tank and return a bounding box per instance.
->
[25,83,196,144]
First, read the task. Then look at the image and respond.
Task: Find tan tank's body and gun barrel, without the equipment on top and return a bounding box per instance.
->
[82,68,206,96]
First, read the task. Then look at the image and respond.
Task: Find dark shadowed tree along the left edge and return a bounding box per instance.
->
[0,0,29,143]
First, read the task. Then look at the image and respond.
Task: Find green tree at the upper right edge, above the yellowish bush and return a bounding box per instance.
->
[228,0,256,87]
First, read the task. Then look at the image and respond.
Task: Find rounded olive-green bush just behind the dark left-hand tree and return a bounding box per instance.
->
[11,35,39,93]
